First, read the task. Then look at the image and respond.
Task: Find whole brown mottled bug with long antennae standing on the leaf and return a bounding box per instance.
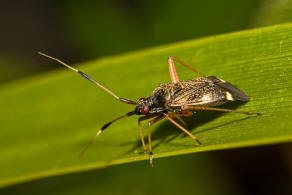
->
[38,52,261,166]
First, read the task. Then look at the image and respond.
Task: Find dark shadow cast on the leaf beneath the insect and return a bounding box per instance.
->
[121,102,251,154]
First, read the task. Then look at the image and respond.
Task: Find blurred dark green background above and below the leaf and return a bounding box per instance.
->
[0,0,292,194]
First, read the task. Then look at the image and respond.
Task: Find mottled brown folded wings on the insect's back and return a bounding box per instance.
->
[168,76,248,107]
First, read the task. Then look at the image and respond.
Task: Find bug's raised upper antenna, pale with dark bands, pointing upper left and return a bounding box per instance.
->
[38,52,137,105]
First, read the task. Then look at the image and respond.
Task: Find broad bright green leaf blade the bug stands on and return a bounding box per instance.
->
[0,24,292,187]
